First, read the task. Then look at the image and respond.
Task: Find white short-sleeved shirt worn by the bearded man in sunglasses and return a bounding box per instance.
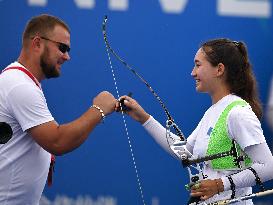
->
[0,62,54,205]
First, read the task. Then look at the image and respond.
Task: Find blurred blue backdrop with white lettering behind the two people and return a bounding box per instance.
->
[0,0,273,205]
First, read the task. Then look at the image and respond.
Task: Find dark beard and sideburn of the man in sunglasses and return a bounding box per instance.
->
[40,48,60,79]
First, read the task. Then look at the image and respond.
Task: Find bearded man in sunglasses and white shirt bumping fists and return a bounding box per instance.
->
[0,14,116,205]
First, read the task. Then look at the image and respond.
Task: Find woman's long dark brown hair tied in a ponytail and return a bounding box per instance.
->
[201,39,262,119]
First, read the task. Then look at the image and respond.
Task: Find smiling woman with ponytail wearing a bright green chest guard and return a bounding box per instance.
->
[117,39,273,204]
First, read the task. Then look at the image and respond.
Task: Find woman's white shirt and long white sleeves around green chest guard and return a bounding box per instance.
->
[143,94,273,205]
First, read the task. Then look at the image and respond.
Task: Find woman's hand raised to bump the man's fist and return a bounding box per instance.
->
[115,95,150,124]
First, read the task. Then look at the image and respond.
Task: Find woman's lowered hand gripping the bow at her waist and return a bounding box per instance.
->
[191,179,224,200]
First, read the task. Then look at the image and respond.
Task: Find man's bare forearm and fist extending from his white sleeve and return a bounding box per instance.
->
[28,92,116,155]
